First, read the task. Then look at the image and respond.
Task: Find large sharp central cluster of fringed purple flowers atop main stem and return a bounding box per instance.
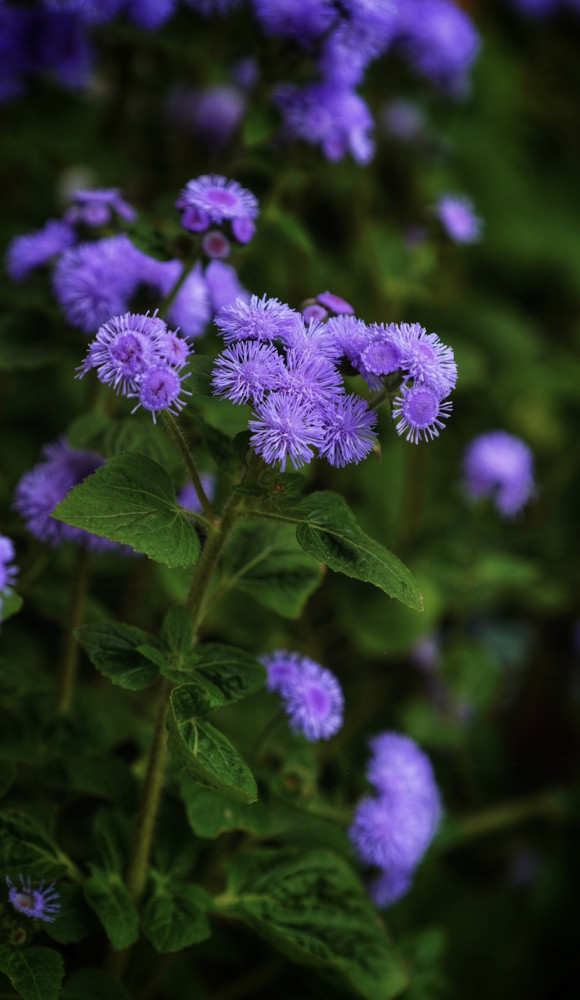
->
[213,292,457,471]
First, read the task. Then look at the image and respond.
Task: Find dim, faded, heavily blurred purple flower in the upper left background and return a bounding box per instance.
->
[168,84,247,150]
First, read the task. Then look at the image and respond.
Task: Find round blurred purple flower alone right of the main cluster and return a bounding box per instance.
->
[463,431,534,517]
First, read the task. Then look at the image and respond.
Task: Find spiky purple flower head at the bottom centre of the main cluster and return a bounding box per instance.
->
[249,392,322,472]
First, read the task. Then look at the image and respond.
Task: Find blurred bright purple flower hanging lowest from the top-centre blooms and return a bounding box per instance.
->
[275,82,374,164]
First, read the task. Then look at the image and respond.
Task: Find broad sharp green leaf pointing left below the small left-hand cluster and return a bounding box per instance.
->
[52,454,200,567]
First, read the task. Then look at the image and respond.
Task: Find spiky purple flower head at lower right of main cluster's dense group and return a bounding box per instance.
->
[319,396,377,467]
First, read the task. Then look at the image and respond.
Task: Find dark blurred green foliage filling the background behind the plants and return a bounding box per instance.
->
[0,0,580,1000]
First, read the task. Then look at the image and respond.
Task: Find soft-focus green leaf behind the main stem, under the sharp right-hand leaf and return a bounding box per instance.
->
[224,521,321,618]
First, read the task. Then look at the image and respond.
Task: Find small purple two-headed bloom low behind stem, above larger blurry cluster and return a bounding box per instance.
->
[262,650,344,742]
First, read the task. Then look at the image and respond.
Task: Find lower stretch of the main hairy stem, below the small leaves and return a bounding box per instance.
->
[127,679,171,906]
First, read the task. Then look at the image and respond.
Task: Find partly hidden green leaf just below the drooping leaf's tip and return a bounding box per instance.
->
[181,774,270,839]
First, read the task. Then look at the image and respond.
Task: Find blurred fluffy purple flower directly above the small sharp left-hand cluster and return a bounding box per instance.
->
[53,235,139,333]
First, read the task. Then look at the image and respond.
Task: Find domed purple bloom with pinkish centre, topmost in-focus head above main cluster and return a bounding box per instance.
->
[175,174,258,246]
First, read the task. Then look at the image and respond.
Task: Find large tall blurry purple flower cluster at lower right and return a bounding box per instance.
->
[348,732,441,907]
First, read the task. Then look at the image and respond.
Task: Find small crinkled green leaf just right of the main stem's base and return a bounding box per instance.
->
[141,873,211,954]
